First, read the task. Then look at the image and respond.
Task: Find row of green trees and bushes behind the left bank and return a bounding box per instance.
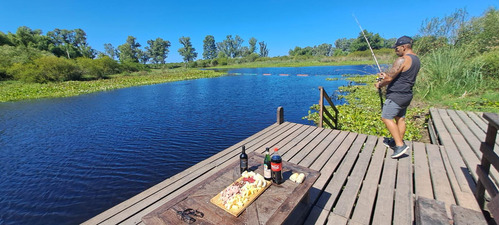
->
[0,26,269,83]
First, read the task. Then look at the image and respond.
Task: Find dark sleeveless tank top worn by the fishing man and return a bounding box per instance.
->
[386,54,420,107]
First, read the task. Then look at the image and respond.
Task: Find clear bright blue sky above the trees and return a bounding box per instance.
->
[0,0,499,62]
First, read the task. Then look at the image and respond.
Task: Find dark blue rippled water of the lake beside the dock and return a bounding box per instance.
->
[0,66,375,224]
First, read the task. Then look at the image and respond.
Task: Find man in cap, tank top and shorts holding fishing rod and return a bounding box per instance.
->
[375,36,420,159]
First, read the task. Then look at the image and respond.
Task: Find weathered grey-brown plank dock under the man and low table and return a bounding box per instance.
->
[84,110,498,224]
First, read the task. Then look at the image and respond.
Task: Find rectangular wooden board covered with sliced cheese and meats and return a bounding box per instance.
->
[210,172,271,217]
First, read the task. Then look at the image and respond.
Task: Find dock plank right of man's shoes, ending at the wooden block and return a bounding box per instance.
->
[413,142,434,199]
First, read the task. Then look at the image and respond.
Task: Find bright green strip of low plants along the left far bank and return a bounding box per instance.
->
[0,68,226,102]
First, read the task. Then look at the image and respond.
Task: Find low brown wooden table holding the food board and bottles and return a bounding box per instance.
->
[142,152,320,225]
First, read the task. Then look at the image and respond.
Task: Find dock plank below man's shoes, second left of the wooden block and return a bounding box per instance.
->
[371,143,398,225]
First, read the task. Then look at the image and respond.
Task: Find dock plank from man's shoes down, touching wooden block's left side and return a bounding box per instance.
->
[393,142,414,224]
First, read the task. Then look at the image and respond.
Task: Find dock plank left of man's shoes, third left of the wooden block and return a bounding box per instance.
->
[350,137,390,224]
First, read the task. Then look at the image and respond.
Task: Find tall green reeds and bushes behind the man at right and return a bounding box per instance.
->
[415,9,499,112]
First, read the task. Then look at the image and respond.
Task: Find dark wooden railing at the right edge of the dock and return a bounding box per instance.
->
[476,113,498,224]
